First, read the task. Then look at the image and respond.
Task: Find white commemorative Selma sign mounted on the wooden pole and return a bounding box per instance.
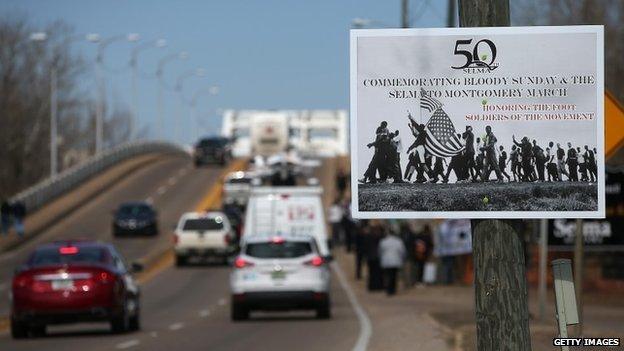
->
[351,26,605,218]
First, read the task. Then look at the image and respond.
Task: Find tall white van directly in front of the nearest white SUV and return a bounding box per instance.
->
[243,186,331,258]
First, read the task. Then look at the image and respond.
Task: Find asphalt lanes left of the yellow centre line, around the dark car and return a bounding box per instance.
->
[0,156,222,316]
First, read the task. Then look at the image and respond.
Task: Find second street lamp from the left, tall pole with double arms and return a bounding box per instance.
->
[87,33,139,154]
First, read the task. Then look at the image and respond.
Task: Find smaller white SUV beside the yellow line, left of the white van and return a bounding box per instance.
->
[174,212,237,266]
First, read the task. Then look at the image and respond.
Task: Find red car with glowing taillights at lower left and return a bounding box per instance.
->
[11,241,142,339]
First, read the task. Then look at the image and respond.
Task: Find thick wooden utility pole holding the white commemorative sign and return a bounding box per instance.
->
[459,0,531,351]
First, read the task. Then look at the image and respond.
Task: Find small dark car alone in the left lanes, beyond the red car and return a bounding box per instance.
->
[113,202,158,236]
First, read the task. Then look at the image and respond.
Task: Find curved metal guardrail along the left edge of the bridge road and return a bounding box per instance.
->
[10,141,189,213]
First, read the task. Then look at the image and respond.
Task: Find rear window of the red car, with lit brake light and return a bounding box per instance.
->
[29,246,106,266]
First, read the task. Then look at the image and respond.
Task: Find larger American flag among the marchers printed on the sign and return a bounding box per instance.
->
[425,108,465,157]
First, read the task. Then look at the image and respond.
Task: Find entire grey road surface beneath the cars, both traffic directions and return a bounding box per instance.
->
[0,157,360,350]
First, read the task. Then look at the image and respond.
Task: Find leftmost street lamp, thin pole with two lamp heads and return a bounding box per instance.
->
[30,32,92,178]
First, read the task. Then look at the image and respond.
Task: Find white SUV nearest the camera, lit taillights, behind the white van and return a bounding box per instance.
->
[230,235,331,321]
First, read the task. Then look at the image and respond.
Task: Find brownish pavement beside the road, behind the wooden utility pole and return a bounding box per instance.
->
[336,248,624,351]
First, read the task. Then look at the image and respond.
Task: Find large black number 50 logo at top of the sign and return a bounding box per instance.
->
[451,39,498,72]
